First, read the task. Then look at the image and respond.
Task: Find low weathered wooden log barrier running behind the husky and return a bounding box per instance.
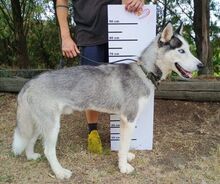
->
[0,70,220,102]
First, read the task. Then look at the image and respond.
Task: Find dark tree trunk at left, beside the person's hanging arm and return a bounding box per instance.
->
[11,0,30,68]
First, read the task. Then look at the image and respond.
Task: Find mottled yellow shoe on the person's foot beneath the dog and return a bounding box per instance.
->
[88,130,103,154]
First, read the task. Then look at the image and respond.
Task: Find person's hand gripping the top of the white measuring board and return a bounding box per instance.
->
[125,0,144,15]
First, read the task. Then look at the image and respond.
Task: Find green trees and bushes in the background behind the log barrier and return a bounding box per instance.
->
[0,0,220,76]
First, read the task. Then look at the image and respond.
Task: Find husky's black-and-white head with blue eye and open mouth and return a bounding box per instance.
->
[156,23,203,79]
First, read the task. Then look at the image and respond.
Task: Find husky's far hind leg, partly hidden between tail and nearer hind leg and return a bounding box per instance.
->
[25,129,41,160]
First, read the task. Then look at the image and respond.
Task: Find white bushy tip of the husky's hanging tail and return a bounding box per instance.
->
[12,127,29,155]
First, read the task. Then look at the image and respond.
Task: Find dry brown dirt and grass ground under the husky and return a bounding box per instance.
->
[0,93,220,184]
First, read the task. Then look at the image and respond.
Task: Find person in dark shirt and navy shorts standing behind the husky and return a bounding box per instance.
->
[56,0,144,153]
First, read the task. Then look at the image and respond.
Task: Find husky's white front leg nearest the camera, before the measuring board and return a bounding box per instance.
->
[118,117,135,174]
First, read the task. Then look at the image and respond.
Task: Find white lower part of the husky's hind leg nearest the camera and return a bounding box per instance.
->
[43,116,72,179]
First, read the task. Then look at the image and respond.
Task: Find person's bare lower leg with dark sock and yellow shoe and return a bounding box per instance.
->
[86,110,102,154]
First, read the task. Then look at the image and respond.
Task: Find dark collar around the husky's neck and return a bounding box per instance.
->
[136,61,162,89]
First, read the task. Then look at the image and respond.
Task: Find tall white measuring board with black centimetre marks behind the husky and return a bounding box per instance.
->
[108,5,156,151]
